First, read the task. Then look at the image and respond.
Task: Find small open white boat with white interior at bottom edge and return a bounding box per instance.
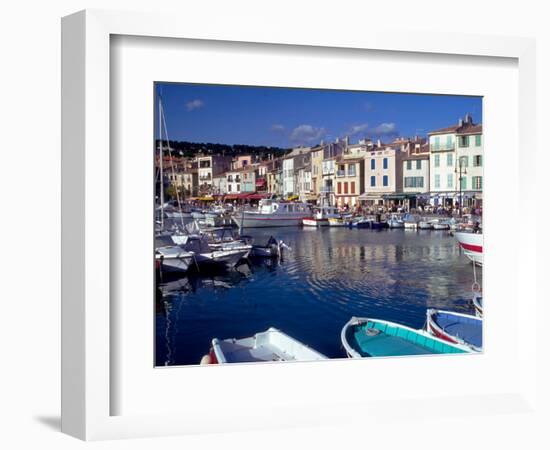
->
[203,328,328,364]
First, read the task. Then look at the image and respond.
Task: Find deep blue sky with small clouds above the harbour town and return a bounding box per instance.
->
[155,83,482,148]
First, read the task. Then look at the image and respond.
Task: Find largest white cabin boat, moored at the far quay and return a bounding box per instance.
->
[233,199,311,228]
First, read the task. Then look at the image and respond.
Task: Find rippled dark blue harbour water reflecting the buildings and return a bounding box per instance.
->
[155,227,481,366]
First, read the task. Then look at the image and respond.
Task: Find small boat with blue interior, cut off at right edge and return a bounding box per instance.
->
[426,308,483,352]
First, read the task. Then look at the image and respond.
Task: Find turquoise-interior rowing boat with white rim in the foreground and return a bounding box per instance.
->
[340,317,471,358]
